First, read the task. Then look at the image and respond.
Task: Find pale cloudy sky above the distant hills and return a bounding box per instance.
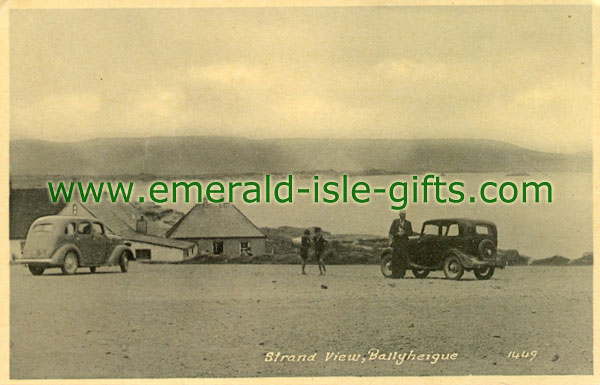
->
[10,6,592,153]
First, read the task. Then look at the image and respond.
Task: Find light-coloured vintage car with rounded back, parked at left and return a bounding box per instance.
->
[15,215,135,275]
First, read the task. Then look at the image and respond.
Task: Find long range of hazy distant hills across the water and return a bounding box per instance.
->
[10,136,592,177]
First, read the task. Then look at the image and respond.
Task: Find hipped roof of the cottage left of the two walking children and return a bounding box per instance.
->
[167,204,266,238]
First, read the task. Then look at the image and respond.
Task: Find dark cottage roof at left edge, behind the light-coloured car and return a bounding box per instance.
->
[8,188,65,239]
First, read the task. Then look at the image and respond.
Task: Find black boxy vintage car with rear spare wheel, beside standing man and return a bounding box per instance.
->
[381,218,504,280]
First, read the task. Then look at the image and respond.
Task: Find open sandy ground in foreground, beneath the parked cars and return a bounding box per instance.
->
[10,263,592,379]
